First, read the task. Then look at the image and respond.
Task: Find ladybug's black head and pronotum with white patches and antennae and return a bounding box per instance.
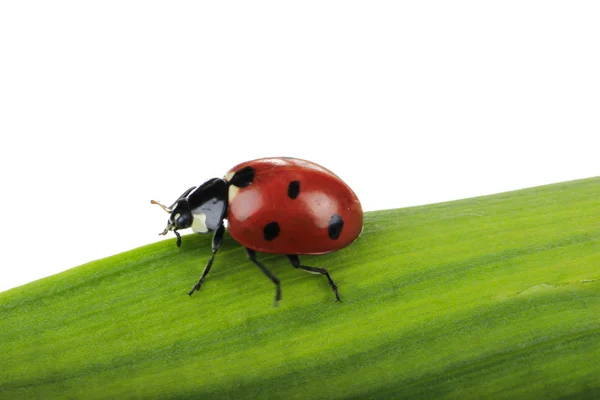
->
[152,178,228,246]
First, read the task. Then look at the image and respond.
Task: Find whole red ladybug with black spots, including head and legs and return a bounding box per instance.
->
[151,157,363,305]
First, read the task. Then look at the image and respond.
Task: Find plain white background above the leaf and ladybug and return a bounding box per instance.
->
[0,0,600,290]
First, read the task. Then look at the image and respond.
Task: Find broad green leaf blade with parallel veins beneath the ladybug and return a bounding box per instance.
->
[0,178,600,399]
